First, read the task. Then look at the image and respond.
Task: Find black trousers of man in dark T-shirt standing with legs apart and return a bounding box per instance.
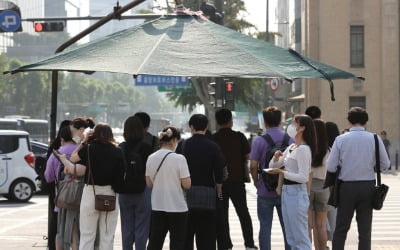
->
[217,182,254,250]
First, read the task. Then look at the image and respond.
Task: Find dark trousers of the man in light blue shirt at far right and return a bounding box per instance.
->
[332,181,375,250]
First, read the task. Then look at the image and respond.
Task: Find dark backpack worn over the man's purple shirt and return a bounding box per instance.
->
[259,133,290,192]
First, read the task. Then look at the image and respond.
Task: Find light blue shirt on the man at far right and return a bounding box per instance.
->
[327,127,390,181]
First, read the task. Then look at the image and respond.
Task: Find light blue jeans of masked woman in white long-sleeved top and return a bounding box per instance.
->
[282,184,312,250]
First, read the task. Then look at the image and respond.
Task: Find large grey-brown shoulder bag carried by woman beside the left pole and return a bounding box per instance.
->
[54,153,85,209]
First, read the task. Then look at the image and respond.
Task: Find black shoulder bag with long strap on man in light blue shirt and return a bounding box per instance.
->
[372,134,389,210]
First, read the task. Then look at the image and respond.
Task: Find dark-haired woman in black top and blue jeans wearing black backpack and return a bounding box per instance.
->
[118,116,153,250]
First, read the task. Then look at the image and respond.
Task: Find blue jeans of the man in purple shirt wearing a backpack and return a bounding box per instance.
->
[257,196,290,250]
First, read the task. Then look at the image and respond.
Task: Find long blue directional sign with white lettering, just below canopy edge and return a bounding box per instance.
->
[135,75,189,86]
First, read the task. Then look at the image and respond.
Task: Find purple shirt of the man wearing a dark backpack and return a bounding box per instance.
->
[250,127,294,198]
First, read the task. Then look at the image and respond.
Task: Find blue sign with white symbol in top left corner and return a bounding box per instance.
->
[0,1,22,32]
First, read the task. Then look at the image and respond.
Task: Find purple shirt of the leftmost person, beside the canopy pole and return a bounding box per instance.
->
[44,144,77,212]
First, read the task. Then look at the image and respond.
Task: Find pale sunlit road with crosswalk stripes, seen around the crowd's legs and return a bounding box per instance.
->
[0,171,400,250]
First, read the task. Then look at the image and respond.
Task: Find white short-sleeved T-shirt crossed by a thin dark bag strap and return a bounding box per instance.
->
[146,149,190,212]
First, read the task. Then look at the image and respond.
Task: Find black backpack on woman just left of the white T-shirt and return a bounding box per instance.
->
[118,142,146,194]
